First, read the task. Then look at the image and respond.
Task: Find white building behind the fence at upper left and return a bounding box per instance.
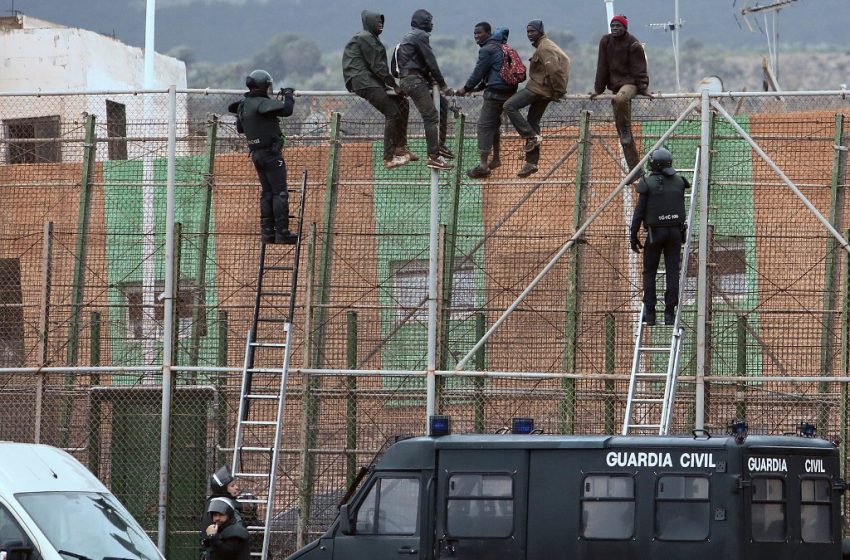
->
[0,14,186,164]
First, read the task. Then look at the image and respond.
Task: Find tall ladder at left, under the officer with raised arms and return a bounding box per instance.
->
[231,170,307,559]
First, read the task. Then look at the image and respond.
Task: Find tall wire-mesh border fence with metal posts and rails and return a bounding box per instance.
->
[0,89,850,559]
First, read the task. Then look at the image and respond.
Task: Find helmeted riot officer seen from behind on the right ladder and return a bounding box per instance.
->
[629,148,691,325]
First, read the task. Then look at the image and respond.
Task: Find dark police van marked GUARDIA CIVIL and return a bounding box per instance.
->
[289,426,846,560]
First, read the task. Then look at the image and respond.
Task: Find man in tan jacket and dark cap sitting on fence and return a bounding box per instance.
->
[504,19,570,177]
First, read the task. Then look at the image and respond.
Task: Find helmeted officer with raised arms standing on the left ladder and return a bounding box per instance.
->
[228,70,298,245]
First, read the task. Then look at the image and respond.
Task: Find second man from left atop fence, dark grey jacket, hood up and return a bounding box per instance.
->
[396,10,454,170]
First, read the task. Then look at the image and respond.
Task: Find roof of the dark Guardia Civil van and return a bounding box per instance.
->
[377,434,837,470]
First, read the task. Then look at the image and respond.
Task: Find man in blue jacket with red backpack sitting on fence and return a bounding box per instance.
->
[456,21,517,179]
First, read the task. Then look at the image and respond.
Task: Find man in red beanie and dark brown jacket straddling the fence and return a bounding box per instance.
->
[590,14,651,180]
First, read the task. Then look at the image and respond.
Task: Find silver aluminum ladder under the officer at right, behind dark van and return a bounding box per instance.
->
[621,148,700,435]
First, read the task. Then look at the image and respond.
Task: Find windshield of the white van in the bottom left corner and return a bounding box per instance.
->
[15,492,161,560]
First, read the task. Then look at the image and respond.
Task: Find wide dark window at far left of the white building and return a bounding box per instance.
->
[6,116,62,164]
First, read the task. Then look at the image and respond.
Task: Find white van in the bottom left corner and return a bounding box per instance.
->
[0,442,163,560]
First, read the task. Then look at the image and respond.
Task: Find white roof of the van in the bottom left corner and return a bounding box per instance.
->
[0,441,108,496]
